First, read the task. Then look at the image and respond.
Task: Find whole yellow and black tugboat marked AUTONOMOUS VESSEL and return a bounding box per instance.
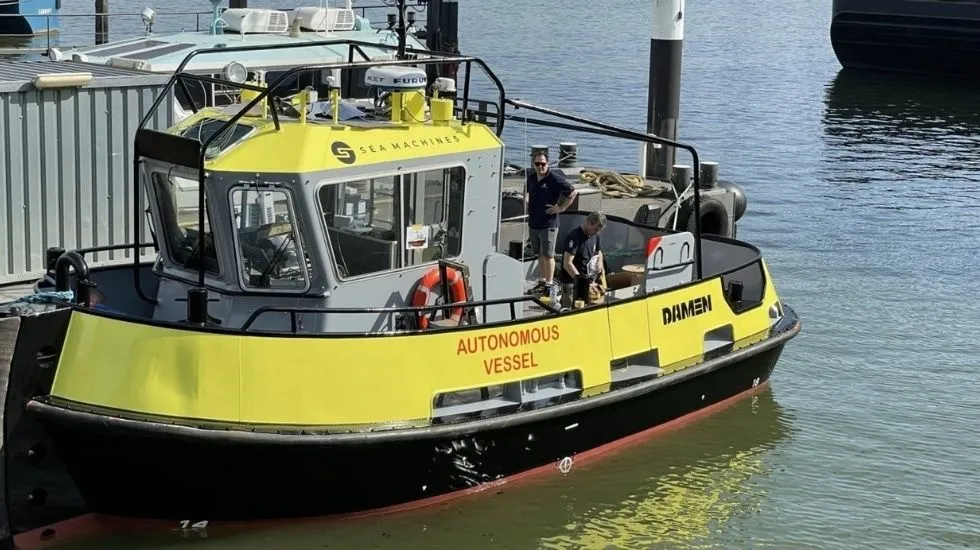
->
[5,23,800,548]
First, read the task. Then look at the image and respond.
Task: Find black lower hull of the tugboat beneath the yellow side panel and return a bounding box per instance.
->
[28,308,799,521]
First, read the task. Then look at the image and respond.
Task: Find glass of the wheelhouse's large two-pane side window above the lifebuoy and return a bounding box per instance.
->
[319,167,466,277]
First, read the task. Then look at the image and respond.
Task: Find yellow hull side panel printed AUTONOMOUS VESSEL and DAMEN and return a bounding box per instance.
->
[52,266,776,425]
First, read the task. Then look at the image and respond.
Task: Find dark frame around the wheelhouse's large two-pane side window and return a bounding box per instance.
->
[313,161,469,283]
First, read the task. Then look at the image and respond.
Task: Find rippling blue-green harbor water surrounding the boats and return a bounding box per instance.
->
[1,0,980,549]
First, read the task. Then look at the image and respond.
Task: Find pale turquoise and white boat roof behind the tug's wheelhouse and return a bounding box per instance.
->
[48,0,436,120]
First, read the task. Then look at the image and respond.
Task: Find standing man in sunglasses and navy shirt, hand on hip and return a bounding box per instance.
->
[524,152,576,301]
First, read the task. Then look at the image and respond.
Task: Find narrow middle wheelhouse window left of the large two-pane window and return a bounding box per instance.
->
[231,188,309,291]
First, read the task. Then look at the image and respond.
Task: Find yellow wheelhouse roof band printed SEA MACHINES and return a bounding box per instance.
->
[171,109,502,173]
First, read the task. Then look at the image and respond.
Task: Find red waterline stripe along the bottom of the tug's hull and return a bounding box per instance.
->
[14,380,769,550]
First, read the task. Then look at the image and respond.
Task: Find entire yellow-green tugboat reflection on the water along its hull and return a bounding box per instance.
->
[49,389,792,549]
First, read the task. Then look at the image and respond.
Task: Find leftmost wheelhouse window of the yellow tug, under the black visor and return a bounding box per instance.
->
[151,172,219,275]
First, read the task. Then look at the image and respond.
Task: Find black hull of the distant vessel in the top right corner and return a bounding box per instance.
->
[830,0,980,78]
